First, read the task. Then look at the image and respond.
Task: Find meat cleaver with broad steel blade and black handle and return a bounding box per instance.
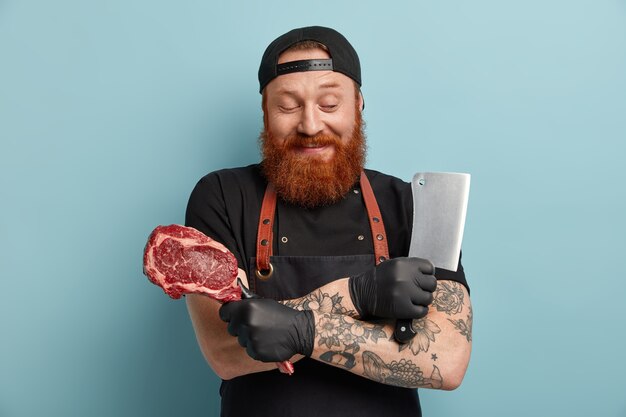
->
[393,172,470,343]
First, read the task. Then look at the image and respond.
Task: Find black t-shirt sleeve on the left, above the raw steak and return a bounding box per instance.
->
[185,173,244,268]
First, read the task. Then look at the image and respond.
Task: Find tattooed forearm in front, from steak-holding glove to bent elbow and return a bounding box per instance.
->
[311,286,471,389]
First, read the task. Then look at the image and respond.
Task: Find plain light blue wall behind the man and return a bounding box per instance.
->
[0,0,626,417]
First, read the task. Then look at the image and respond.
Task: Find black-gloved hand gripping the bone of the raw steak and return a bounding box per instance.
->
[220,298,315,362]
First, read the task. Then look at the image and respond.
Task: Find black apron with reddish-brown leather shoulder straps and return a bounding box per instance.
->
[220,174,421,417]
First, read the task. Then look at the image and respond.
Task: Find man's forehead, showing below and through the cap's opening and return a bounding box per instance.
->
[266,48,354,97]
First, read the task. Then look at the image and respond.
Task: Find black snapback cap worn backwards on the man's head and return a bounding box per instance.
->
[259,26,361,92]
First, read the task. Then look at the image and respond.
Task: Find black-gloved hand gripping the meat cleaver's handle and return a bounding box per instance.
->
[348,258,437,319]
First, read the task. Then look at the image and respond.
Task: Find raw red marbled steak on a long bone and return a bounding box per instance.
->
[143,224,293,375]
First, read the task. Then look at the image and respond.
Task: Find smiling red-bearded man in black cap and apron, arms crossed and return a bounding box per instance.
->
[186,27,472,417]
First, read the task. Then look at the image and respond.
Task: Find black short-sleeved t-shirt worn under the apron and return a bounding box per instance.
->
[185,165,469,289]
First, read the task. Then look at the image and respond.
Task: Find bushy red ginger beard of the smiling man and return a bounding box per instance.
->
[259,109,367,209]
